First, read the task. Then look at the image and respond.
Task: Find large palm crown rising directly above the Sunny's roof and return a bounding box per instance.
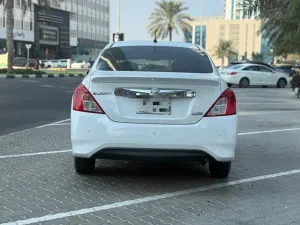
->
[148,0,193,41]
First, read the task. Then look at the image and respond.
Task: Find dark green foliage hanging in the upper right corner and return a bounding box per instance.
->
[242,0,300,55]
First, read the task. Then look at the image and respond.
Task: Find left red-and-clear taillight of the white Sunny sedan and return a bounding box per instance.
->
[73,84,105,114]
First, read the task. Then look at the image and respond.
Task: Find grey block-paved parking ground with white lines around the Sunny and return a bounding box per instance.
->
[0,84,300,225]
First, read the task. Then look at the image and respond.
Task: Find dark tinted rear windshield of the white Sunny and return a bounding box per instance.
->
[97,46,213,73]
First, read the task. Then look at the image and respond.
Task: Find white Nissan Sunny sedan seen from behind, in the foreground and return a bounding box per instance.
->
[71,41,238,178]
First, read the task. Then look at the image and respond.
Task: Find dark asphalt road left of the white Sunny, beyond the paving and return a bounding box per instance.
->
[0,77,82,135]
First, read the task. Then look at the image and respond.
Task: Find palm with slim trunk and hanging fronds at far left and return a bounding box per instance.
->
[0,0,61,73]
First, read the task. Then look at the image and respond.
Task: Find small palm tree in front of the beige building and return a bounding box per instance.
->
[214,39,236,68]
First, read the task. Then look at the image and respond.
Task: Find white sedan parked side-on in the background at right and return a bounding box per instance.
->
[219,63,291,88]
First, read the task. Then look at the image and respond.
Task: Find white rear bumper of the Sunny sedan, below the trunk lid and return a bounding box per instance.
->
[71,110,237,161]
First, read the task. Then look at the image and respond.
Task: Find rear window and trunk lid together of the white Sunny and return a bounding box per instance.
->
[89,46,221,125]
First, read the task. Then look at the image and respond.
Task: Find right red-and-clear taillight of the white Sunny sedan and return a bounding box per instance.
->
[205,89,236,117]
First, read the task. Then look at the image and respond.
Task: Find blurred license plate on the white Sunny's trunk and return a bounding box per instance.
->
[136,98,171,115]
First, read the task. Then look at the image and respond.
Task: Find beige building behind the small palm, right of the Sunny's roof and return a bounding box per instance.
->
[189,16,269,66]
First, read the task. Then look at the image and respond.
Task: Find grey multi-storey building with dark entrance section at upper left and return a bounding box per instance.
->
[0,0,110,60]
